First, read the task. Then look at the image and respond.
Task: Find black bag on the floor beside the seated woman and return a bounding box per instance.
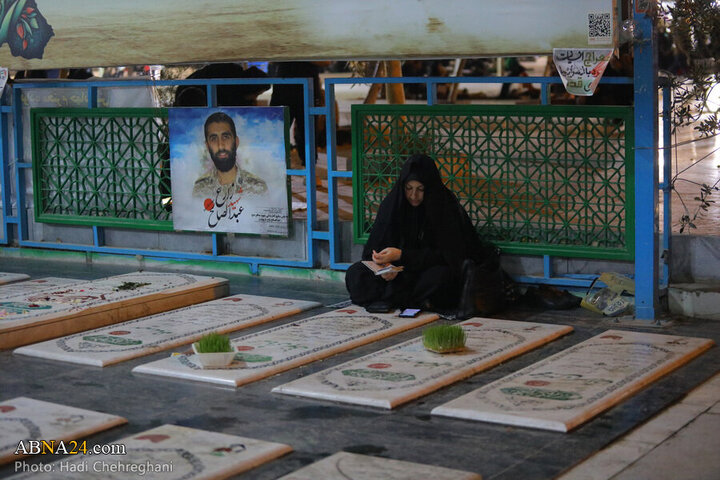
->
[456,259,515,320]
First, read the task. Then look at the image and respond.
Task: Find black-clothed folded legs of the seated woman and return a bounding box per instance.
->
[345,262,459,308]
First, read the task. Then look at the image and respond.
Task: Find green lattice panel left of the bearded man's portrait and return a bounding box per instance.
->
[31,108,172,230]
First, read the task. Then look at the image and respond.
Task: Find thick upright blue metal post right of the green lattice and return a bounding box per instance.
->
[633,0,658,320]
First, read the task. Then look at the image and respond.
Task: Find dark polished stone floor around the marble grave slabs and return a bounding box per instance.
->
[0,257,720,480]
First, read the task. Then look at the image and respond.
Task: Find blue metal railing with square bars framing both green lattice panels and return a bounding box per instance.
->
[0,73,670,300]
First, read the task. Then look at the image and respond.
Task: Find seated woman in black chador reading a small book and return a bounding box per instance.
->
[345,154,499,317]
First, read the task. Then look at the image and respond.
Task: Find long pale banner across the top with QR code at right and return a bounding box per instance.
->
[0,0,617,70]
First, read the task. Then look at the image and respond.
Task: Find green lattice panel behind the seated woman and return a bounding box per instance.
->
[352,105,635,260]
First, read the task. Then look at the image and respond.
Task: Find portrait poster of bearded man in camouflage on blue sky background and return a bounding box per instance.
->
[168,107,290,237]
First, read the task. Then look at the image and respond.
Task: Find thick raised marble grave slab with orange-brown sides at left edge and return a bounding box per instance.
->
[0,272,228,348]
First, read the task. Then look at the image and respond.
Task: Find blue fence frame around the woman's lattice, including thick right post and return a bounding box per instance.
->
[324,72,671,320]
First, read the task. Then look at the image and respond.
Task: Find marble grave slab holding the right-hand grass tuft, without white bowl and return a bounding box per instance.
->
[273,317,572,409]
